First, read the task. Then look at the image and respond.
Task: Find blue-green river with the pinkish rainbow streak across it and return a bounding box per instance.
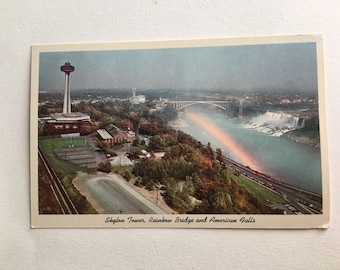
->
[175,106,322,194]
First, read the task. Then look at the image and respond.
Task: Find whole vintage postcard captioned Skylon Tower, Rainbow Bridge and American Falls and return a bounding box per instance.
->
[30,35,330,229]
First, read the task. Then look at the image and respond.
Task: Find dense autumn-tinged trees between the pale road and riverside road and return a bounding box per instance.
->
[132,130,265,214]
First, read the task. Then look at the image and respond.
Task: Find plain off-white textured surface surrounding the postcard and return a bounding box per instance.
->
[0,0,340,269]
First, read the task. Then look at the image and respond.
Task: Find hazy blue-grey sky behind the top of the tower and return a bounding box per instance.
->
[39,43,317,91]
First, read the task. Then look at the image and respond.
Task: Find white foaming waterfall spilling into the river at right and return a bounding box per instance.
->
[246,111,305,136]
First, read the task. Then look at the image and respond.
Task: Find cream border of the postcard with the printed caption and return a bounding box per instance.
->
[30,35,330,229]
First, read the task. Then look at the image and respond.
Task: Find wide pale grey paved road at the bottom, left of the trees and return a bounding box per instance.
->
[83,175,166,214]
